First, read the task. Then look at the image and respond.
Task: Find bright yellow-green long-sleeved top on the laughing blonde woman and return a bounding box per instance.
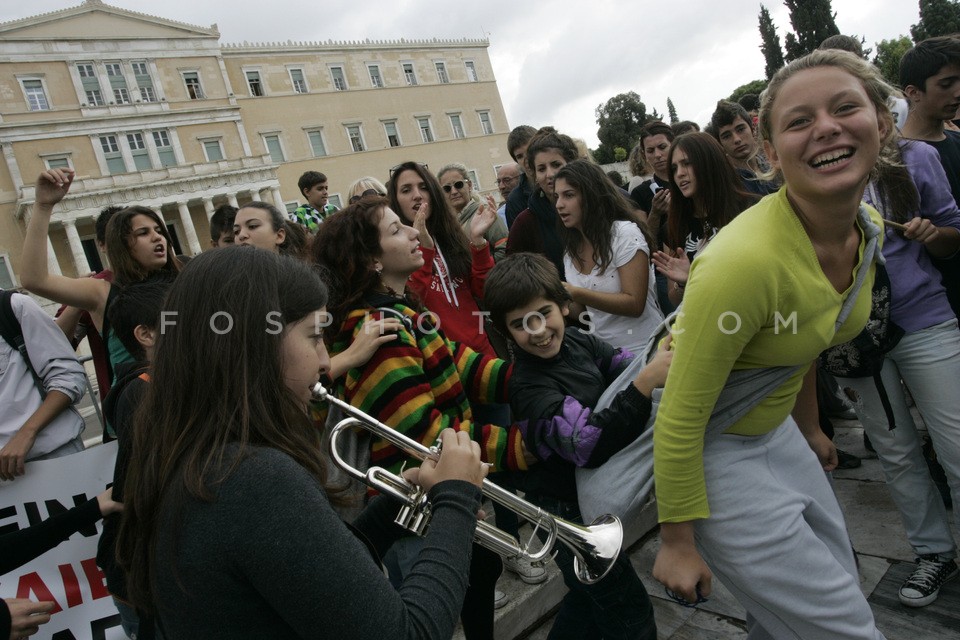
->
[653,189,882,522]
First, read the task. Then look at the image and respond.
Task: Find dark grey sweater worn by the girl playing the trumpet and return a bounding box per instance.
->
[154,448,480,640]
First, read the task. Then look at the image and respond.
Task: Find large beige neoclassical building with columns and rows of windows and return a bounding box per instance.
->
[0,0,511,287]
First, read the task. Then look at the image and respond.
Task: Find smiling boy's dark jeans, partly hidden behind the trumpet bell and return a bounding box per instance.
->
[526,493,657,640]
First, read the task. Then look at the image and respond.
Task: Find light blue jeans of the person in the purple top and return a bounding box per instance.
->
[838,319,960,558]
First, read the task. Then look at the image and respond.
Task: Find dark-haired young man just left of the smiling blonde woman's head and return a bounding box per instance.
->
[707,100,777,197]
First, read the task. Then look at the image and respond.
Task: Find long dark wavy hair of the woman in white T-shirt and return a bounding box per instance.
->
[555,160,653,273]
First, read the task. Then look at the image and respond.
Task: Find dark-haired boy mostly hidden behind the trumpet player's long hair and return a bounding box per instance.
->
[97,274,173,639]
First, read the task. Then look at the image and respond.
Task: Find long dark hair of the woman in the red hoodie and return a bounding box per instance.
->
[387,161,473,278]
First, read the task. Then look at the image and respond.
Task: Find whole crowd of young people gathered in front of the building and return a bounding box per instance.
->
[0,32,960,640]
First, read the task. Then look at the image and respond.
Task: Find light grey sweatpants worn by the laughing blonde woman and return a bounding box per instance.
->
[696,418,883,640]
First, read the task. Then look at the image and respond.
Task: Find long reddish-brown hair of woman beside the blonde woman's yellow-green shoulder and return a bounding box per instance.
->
[667,132,757,249]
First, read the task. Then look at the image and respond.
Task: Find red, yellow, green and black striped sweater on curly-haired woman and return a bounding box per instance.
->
[334,306,526,472]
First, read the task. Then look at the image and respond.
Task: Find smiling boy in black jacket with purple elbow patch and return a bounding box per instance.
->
[484,253,671,640]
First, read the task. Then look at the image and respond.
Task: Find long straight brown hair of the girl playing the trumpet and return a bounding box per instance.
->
[117,246,338,611]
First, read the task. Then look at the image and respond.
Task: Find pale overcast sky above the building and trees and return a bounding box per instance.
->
[0,0,919,147]
